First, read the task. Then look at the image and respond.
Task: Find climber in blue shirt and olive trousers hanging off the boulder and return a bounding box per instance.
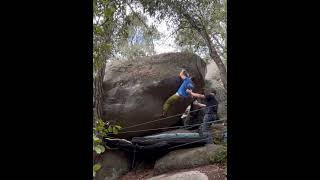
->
[161,69,194,117]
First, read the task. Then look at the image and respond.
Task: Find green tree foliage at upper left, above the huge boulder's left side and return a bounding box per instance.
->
[93,0,160,72]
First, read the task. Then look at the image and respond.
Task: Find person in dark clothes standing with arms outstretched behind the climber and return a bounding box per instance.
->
[186,89,218,144]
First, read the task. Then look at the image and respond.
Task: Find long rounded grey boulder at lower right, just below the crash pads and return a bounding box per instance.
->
[154,144,227,175]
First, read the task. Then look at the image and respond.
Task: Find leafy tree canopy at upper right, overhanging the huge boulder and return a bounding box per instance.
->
[139,0,227,60]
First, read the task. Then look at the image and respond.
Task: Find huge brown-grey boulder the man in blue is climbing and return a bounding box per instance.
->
[103,53,206,138]
